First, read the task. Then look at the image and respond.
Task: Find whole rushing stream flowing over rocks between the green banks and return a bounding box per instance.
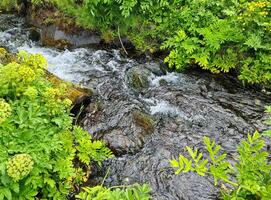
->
[0,15,270,200]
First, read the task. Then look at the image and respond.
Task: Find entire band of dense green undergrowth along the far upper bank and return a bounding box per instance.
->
[5,0,271,85]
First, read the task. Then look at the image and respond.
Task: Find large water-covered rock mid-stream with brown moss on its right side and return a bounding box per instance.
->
[82,95,153,155]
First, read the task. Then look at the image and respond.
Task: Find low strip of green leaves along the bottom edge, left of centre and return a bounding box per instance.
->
[76,184,151,200]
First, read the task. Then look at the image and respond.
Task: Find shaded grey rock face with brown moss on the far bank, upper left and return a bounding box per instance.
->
[25,6,101,49]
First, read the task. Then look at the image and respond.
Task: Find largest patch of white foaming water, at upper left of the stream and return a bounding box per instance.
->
[18,44,111,84]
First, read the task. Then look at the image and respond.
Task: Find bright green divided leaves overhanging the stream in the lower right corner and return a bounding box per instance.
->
[170,132,271,200]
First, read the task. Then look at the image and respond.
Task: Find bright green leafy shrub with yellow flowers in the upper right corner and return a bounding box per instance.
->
[163,0,271,83]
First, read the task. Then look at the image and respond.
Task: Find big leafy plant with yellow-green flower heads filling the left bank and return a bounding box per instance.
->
[0,52,112,200]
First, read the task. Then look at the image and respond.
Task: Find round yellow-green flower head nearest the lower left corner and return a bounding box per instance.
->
[7,154,34,182]
